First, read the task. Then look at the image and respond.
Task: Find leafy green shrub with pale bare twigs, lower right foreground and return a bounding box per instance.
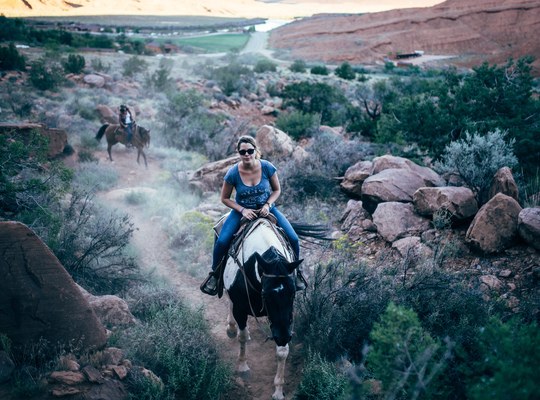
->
[366,303,450,398]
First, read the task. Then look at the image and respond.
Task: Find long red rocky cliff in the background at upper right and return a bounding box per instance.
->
[269,0,540,70]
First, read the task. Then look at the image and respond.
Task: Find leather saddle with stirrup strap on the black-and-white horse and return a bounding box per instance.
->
[209,213,292,298]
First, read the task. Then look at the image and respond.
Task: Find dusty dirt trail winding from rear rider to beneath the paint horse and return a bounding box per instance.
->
[94,146,302,400]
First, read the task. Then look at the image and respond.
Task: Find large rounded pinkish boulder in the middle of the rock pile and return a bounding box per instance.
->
[362,168,425,212]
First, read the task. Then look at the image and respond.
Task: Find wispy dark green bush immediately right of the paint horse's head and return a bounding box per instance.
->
[295,260,391,362]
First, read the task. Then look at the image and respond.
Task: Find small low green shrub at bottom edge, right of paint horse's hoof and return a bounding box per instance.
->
[295,353,347,400]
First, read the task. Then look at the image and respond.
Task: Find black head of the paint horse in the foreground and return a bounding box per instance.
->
[256,247,303,346]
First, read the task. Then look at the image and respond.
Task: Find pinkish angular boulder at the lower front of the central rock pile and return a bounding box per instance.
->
[373,201,430,242]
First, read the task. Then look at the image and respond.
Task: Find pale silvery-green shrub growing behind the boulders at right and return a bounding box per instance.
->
[435,129,517,204]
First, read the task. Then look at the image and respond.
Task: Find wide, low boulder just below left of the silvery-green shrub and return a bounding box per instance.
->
[413,186,478,220]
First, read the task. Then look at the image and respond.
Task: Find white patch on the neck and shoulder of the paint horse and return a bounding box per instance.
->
[223,220,293,290]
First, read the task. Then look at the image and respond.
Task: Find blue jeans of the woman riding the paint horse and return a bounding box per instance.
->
[212,207,300,271]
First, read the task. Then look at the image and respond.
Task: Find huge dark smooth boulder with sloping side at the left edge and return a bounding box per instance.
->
[0,222,107,349]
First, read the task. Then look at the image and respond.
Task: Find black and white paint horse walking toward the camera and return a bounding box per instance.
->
[223,219,302,400]
